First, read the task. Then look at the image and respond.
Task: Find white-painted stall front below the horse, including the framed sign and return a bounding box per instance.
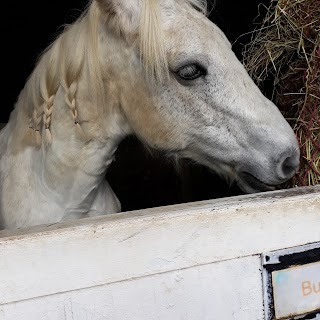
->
[0,186,320,320]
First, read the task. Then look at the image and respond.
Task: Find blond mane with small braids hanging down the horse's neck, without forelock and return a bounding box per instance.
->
[17,1,105,147]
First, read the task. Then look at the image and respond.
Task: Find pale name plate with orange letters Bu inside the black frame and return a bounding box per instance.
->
[271,262,320,319]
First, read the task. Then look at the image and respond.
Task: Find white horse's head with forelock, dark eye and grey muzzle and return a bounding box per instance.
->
[96,0,299,192]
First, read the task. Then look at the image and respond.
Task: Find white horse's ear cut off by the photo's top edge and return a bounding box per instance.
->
[95,0,141,33]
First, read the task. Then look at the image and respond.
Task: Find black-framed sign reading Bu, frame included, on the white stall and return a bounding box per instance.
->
[261,242,320,320]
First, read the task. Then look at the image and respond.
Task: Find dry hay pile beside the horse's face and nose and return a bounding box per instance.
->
[243,0,320,187]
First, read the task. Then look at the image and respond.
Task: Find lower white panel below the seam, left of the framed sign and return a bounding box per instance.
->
[0,256,263,320]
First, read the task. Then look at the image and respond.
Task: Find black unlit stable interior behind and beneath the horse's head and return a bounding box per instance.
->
[0,0,270,210]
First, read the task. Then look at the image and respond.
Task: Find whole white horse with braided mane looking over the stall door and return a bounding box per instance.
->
[0,0,299,228]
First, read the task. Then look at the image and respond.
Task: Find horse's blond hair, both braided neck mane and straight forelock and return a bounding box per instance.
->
[12,0,207,146]
